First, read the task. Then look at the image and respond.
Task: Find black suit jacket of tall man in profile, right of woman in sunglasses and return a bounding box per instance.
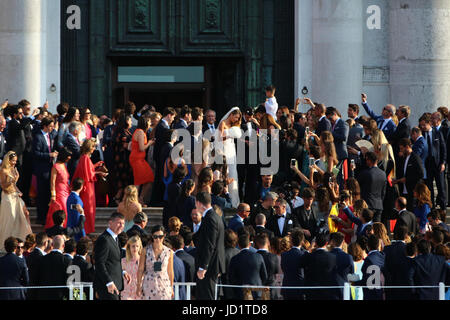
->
[195,209,225,278]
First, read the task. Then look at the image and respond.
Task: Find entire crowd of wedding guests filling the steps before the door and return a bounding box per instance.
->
[0,86,450,300]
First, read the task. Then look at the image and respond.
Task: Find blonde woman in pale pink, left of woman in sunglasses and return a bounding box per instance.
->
[121,236,142,300]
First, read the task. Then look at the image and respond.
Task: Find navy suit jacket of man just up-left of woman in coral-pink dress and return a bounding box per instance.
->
[32,131,55,179]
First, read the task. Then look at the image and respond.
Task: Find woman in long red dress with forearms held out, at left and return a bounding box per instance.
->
[72,139,107,235]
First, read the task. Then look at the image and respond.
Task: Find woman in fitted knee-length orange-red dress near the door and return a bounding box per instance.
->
[130,117,155,205]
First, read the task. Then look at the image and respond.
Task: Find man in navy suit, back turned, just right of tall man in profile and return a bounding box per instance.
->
[228,234,267,300]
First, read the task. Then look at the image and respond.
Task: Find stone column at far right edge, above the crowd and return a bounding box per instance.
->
[389,0,450,125]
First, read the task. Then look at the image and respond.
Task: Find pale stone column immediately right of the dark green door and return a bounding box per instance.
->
[311,0,363,114]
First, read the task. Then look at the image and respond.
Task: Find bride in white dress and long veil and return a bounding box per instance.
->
[214,107,242,208]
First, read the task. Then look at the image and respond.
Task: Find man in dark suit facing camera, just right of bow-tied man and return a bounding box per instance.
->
[293,188,317,241]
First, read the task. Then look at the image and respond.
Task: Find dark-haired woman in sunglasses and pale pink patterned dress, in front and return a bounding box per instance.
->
[136,226,174,300]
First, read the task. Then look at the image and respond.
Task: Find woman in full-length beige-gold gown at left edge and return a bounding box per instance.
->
[0,151,32,250]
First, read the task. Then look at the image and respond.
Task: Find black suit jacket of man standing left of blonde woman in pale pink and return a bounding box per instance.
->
[94,231,123,292]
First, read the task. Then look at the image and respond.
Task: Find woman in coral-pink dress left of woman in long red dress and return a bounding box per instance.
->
[45,148,72,229]
